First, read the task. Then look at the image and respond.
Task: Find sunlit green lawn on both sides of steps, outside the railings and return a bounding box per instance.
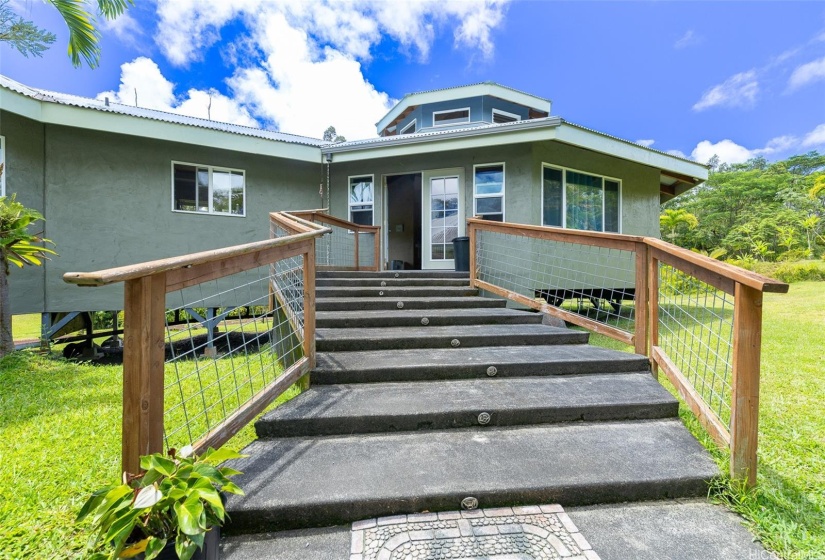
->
[0,282,825,559]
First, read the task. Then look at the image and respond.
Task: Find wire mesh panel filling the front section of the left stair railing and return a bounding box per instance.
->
[164,256,303,448]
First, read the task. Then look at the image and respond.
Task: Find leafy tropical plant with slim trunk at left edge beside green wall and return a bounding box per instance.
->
[0,187,55,357]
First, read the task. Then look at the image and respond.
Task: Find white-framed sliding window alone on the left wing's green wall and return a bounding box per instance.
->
[172,162,241,216]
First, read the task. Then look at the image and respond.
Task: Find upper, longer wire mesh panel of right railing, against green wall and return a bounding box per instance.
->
[476,229,645,333]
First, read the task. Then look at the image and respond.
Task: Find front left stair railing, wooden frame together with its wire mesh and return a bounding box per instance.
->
[63,212,330,473]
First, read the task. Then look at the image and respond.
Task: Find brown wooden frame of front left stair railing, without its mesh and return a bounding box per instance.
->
[63,212,330,473]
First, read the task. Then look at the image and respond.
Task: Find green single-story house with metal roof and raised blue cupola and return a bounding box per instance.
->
[0,76,707,322]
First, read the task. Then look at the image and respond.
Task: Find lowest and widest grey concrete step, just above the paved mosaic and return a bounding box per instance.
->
[226,419,718,533]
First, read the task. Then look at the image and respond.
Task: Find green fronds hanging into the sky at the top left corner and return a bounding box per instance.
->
[0,0,134,68]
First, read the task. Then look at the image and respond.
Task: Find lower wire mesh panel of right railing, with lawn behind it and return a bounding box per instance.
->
[658,263,734,426]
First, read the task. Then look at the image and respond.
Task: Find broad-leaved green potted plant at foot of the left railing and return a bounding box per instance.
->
[77,446,244,560]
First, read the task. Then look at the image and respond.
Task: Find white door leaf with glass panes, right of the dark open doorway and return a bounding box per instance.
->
[421,168,464,269]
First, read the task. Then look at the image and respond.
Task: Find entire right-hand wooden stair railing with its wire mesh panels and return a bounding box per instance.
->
[467,218,788,485]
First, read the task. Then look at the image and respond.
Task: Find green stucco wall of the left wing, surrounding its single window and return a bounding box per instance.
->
[4,119,321,313]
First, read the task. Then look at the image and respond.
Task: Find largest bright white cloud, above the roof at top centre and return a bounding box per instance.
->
[150,0,509,139]
